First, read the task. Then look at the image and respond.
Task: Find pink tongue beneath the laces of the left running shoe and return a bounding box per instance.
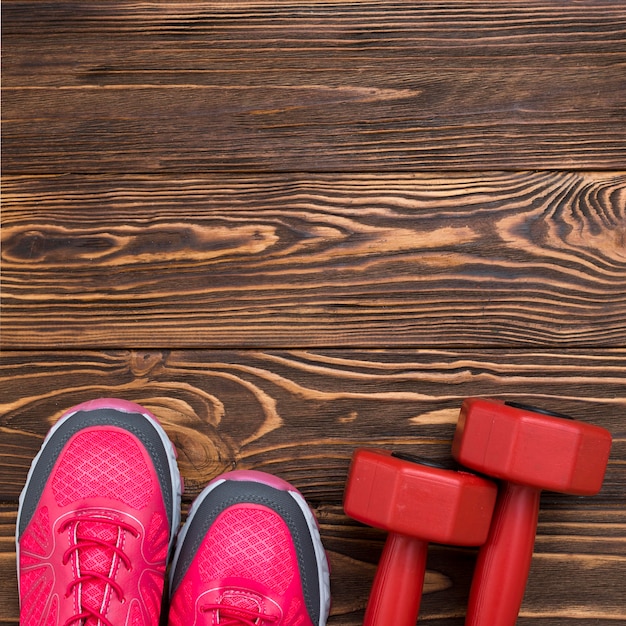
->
[76,521,123,626]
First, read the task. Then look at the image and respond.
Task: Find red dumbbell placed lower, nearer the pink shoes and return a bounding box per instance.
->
[344,448,497,626]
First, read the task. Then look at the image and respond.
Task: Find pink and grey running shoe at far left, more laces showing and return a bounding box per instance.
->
[16,399,181,626]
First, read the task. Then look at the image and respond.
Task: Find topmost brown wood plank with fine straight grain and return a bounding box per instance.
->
[2,0,626,174]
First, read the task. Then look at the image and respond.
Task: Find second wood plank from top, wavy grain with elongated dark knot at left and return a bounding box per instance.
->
[1,172,626,348]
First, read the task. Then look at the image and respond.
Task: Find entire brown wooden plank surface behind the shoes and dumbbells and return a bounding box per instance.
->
[0,0,626,626]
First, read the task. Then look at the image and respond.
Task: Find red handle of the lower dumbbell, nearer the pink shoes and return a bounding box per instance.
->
[363,533,428,626]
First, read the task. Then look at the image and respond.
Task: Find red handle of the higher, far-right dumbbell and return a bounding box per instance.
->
[465,483,541,626]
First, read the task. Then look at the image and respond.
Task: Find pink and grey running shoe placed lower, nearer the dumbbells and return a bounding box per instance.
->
[169,471,330,626]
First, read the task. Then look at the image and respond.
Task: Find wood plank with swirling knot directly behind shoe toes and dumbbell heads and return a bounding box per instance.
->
[0,348,626,500]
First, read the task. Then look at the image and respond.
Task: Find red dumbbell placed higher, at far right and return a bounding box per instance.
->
[452,398,611,626]
